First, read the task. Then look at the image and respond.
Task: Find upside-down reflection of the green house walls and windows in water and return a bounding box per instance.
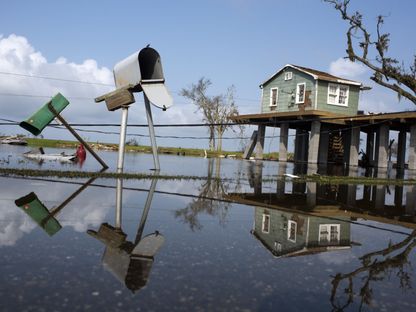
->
[252,207,351,257]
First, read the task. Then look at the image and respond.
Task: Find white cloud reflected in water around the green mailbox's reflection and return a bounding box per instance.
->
[0,178,115,247]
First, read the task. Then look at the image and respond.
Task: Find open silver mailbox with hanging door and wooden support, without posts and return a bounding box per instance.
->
[95,47,173,111]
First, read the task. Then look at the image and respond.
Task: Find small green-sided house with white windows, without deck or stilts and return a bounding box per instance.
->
[260,64,362,115]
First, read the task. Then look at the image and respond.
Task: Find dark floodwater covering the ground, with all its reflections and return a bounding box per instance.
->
[0,145,416,311]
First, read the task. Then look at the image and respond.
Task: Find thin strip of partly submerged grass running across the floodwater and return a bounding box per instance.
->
[0,168,416,186]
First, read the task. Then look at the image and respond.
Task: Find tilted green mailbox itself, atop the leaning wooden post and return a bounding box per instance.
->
[20,93,69,135]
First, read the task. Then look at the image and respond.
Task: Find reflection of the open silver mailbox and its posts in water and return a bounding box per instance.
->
[87,177,165,292]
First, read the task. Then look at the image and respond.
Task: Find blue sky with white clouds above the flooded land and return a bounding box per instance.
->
[0,0,416,149]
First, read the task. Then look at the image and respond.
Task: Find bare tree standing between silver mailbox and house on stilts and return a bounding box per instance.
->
[180,77,238,152]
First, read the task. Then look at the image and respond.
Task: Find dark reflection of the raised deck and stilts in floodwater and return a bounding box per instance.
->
[247,163,416,227]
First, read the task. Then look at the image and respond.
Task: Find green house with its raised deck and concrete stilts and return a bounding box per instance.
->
[231,64,416,170]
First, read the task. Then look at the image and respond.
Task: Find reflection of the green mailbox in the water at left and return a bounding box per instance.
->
[15,192,62,236]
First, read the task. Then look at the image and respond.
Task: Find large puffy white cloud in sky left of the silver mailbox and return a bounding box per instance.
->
[0,34,113,120]
